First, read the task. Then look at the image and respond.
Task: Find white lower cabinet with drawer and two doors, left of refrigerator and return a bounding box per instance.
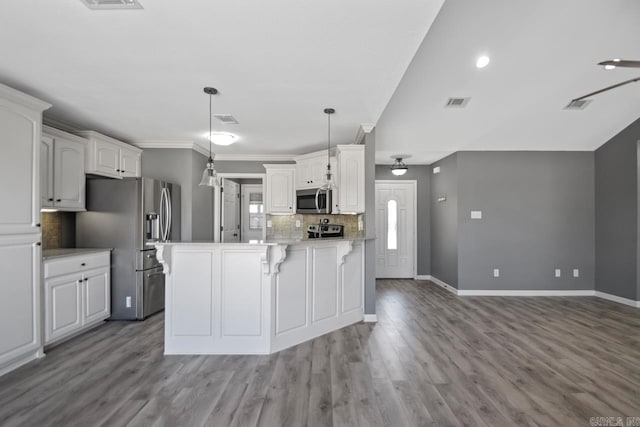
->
[44,251,111,344]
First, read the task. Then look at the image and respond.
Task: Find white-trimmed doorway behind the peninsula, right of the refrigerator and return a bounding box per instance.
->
[213,173,266,243]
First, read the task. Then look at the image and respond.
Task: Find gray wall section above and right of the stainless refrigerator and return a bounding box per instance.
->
[142,148,213,240]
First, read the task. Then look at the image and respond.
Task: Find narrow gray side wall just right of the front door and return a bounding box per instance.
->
[430,153,458,288]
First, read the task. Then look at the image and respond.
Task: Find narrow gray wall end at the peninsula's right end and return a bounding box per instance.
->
[364,129,376,314]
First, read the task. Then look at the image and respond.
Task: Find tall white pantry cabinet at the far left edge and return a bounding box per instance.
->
[0,84,51,375]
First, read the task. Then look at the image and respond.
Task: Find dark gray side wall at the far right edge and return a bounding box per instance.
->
[595,119,640,300]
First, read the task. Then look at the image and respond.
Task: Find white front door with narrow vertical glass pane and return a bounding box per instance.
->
[376,181,416,278]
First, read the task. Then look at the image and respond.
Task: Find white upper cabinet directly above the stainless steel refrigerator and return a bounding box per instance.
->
[77,131,142,178]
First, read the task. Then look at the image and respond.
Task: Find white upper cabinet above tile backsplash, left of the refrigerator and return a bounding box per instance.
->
[40,126,87,211]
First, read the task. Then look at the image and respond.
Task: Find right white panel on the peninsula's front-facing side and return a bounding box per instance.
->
[221,250,264,337]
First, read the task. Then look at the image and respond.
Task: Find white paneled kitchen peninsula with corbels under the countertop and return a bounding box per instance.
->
[155,239,364,354]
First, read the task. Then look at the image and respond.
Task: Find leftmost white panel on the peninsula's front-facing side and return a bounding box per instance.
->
[167,249,214,336]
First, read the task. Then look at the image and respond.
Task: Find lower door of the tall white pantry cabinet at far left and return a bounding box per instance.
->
[0,234,41,366]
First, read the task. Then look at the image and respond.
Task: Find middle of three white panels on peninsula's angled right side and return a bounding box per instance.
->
[312,245,338,323]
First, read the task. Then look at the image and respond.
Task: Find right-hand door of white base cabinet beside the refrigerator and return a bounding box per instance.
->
[82,268,111,325]
